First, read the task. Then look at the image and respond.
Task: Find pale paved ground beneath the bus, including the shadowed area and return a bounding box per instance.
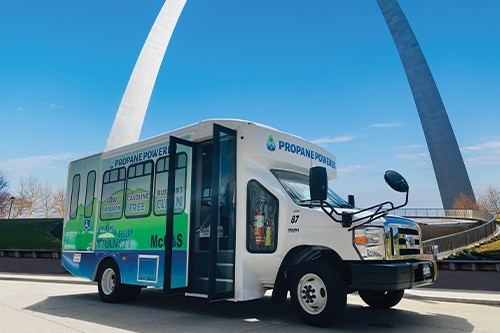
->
[0,274,500,333]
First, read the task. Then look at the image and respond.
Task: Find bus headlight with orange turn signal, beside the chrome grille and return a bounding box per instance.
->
[354,227,385,260]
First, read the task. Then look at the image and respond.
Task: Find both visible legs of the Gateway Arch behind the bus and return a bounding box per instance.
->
[105,0,475,208]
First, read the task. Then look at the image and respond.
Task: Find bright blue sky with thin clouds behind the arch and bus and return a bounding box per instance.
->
[0,0,500,207]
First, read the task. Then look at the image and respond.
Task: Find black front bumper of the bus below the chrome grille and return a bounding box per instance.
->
[349,260,437,290]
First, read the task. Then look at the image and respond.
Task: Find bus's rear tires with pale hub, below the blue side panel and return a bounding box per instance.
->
[97,260,141,303]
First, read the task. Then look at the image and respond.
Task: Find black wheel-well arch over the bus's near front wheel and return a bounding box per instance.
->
[272,245,351,303]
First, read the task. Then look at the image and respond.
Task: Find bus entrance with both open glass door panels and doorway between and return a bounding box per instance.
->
[163,124,236,301]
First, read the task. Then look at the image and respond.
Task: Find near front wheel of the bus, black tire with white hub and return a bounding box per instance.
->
[290,261,347,326]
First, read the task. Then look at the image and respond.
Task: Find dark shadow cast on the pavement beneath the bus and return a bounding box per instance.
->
[27,289,474,333]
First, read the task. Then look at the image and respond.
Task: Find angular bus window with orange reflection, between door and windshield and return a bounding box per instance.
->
[247,180,278,253]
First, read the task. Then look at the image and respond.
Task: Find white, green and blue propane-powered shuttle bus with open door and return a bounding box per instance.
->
[62,119,437,326]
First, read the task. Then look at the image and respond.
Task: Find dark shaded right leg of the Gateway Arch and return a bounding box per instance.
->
[377,0,475,209]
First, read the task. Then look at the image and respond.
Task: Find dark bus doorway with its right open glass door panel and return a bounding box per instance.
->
[190,125,236,300]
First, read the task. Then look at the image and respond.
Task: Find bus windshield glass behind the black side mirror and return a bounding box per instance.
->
[271,170,350,208]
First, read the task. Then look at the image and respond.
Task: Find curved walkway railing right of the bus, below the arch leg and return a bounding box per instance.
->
[395,208,496,257]
